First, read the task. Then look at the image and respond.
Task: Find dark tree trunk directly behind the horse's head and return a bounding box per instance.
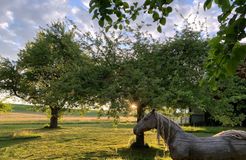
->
[135,104,145,147]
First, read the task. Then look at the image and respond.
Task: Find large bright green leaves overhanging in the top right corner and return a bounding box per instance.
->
[204,0,246,86]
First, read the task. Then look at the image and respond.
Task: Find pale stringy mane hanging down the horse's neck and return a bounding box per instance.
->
[155,112,182,143]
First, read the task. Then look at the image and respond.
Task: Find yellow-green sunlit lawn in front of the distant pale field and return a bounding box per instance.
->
[0,121,170,160]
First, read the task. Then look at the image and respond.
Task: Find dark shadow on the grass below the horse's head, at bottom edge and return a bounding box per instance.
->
[80,147,169,160]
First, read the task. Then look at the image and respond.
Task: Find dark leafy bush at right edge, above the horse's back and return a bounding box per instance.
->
[205,76,246,126]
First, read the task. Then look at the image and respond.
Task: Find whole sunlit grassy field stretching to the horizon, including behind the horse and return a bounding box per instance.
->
[0,106,245,160]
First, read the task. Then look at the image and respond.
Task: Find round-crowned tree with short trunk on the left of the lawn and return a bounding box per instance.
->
[0,22,92,128]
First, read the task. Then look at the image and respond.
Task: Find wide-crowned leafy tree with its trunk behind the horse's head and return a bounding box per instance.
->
[79,26,208,147]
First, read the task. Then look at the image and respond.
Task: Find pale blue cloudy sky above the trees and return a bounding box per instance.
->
[0,0,223,60]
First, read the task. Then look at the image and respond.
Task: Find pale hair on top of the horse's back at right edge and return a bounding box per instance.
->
[214,130,246,140]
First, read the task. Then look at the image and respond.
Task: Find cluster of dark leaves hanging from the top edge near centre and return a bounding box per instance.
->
[89,0,173,32]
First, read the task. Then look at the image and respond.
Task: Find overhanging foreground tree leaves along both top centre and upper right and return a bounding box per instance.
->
[89,0,246,86]
